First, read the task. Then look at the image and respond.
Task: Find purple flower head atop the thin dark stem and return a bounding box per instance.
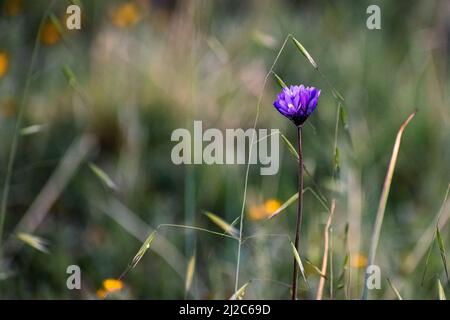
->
[273,85,320,126]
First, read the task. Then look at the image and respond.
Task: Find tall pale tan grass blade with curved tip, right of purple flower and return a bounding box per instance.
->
[362,111,416,299]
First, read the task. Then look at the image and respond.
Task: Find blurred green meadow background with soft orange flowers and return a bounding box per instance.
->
[0,0,450,299]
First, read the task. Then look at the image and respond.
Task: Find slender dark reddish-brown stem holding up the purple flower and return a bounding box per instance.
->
[292,126,303,300]
